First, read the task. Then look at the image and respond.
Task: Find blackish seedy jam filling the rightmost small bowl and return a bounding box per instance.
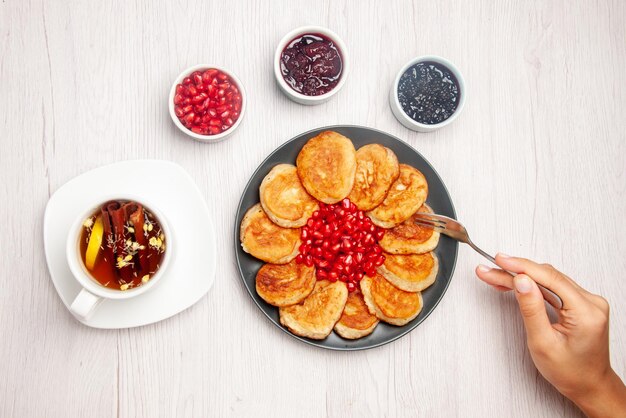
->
[398,61,461,125]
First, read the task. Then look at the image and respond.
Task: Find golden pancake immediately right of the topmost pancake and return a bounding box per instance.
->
[348,144,400,210]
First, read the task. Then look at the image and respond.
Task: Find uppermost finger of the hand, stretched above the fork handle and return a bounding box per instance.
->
[496,253,585,308]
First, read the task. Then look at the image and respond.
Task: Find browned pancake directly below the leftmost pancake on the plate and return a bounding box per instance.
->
[256,261,316,306]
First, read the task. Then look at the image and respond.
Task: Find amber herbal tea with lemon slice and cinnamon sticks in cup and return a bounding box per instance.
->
[80,200,166,290]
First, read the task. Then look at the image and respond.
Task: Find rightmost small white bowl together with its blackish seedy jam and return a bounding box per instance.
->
[389,55,467,132]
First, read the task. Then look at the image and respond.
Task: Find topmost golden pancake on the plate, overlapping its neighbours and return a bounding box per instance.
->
[296,131,356,204]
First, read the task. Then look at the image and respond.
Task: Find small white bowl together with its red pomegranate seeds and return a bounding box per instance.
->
[169,64,246,142]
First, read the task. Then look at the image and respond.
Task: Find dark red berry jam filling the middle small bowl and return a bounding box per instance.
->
[280,33,343,96]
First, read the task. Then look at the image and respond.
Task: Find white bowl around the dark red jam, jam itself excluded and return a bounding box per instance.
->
[274,26,350,105]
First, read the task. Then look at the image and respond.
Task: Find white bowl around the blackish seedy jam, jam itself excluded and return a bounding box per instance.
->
[389,55,467,132]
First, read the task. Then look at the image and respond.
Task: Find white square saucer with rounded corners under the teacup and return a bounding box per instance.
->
[43,160,216,328]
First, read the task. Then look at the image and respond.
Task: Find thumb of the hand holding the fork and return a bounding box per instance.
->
[513,274,552,340]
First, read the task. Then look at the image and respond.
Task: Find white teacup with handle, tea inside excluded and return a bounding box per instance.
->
[66,195,172,319]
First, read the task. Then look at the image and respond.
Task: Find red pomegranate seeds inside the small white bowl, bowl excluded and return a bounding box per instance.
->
[174,68,241,135]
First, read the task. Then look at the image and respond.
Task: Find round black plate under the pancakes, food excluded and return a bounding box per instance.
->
[234,125,458,350]
